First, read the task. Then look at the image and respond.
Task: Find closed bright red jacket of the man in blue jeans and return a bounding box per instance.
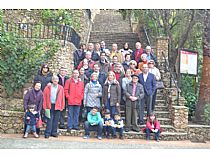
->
[64,78,84,106]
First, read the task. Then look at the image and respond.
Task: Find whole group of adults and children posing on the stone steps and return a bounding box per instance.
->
[24,41,161,140]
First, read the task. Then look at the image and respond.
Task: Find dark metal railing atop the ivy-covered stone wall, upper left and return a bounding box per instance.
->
[2,23,81,48]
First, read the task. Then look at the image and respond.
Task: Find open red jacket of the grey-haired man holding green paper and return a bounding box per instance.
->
[43,84,65,111]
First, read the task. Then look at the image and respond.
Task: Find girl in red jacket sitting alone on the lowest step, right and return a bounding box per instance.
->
[146,113,161,142]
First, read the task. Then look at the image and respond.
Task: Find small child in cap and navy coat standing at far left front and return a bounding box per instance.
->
[23,105,39,138]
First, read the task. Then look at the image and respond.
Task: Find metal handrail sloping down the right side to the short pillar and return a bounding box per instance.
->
[161,51,181,106]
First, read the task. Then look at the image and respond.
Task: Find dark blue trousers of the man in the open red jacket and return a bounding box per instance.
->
[45,104,60,136]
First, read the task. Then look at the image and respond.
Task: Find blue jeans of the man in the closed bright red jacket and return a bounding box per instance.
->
[68,105,80,129]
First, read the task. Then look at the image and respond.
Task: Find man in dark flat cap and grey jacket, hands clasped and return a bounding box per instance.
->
[125,74,144,132]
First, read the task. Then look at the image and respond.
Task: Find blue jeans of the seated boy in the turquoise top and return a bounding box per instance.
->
[85,121,103,137]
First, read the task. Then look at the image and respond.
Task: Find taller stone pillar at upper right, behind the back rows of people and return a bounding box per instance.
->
[155,37,169,62]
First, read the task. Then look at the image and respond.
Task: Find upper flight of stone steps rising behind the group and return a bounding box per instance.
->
[89,10,139,49]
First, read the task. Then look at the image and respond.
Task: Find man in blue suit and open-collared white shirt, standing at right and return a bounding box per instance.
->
[139,64,156,125]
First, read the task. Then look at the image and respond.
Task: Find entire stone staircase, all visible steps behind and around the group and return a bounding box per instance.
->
[38,10,187,140]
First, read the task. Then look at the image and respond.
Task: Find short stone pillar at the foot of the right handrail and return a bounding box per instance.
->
[171,106,188,131]
